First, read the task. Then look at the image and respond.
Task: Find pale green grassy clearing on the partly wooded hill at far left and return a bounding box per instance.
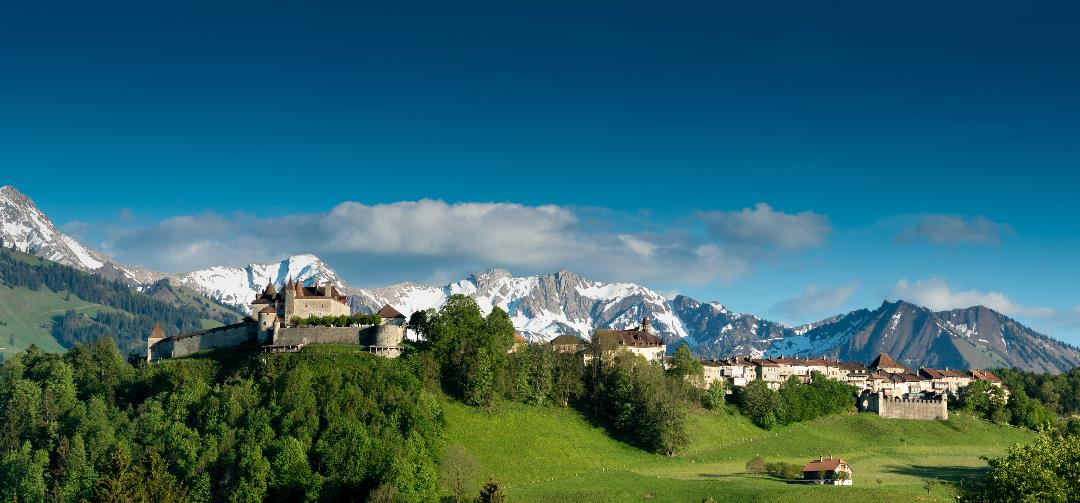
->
[0,286,112,356]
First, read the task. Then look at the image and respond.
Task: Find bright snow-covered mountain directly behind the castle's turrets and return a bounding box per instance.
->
[165,255,348,313]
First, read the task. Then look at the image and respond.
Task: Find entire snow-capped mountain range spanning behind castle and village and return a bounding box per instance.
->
[6,186,1080,372]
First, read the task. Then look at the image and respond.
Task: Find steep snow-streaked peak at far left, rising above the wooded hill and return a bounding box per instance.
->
[0,186,108,271]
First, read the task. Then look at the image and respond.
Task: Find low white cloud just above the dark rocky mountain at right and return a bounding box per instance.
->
[891,277,1057,318]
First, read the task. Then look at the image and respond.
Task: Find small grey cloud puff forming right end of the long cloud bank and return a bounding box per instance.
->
[698,203,832,250]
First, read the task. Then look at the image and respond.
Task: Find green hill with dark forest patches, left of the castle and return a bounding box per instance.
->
[0,248,240,357]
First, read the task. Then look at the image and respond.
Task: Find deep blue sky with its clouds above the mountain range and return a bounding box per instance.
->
[0,1,1080,343]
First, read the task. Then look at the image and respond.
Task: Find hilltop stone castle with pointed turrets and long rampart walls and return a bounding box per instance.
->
[146,278,406,362]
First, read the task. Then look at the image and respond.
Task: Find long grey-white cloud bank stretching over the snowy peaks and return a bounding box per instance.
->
[66,200,828,286]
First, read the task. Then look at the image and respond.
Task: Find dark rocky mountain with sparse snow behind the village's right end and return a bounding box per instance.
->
[766,301,1080,372]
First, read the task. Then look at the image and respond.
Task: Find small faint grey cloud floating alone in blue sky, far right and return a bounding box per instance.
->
[893,215,1014,245]
